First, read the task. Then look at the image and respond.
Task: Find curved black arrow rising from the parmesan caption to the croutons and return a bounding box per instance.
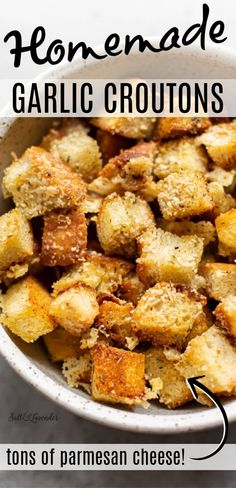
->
[186,376,229,461]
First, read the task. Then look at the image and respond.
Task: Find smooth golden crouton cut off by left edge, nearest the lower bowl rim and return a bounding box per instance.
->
[1,276,55,342]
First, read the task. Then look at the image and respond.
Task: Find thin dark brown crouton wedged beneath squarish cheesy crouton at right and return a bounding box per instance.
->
[158,219,216,246]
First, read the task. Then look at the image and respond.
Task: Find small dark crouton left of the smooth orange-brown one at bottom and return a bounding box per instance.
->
[62,352,92,393]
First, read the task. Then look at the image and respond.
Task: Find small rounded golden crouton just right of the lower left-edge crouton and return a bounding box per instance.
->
[50,285,99,336]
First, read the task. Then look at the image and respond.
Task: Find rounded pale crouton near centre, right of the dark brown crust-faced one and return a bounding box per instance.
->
[97,192,155,257]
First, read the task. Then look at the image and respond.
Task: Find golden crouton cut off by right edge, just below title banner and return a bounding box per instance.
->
[198,121,236,170]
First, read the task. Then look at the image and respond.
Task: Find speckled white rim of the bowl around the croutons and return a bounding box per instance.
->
[0,38,236,434]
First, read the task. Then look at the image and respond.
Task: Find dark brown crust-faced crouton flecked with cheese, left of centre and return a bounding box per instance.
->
[41,210,87,266]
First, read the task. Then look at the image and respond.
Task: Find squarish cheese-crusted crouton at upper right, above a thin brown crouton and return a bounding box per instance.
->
[157,170,214,220]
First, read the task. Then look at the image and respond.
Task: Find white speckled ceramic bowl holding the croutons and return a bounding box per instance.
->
[0,39,236,433]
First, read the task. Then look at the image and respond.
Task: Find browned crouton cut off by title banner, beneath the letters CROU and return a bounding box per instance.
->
[90,117,156,139]
